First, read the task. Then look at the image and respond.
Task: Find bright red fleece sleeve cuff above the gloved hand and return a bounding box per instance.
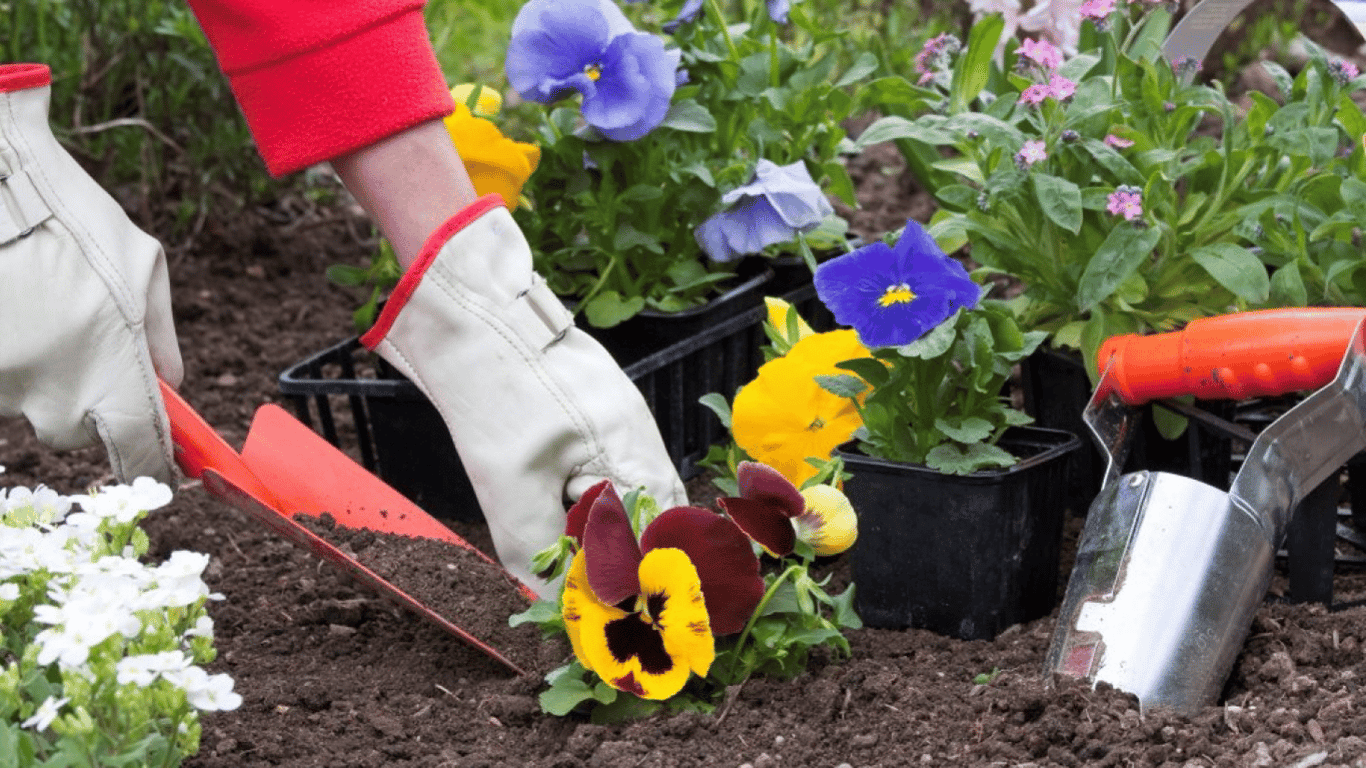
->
[189,0,455,176]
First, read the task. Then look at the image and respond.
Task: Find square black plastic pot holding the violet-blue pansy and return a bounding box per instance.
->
[840,426,1081,640]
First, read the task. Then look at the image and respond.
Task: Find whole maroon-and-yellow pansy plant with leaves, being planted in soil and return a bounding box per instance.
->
[512,462,862,723]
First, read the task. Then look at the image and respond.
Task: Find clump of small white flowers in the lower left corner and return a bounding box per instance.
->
[0,467,242,767]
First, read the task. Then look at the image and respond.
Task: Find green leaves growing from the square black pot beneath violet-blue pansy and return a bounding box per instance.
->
[817,299,1045,474]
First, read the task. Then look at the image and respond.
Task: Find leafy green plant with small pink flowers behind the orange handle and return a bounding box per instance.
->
[874,0,1366,376]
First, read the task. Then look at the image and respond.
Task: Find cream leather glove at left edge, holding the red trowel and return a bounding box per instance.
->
[0,64,183,482]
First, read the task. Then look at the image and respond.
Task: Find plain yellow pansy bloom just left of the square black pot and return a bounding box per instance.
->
[731,329,870,486]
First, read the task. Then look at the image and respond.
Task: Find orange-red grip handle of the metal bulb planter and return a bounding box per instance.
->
[1096,307,1366,404]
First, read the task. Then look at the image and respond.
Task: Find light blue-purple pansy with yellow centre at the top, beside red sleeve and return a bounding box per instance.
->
[505,0,680,141]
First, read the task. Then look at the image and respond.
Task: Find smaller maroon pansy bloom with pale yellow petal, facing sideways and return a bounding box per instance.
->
[717,462,858,558]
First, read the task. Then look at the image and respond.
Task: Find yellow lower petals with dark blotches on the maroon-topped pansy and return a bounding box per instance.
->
[563,548,716,700]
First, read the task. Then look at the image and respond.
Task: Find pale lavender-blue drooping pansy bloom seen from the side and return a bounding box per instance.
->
[693,160,835,261]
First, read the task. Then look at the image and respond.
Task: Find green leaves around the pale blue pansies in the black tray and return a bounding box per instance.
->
[516,1,877,327]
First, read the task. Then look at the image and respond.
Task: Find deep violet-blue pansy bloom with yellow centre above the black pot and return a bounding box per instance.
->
[816,221,982,348]
